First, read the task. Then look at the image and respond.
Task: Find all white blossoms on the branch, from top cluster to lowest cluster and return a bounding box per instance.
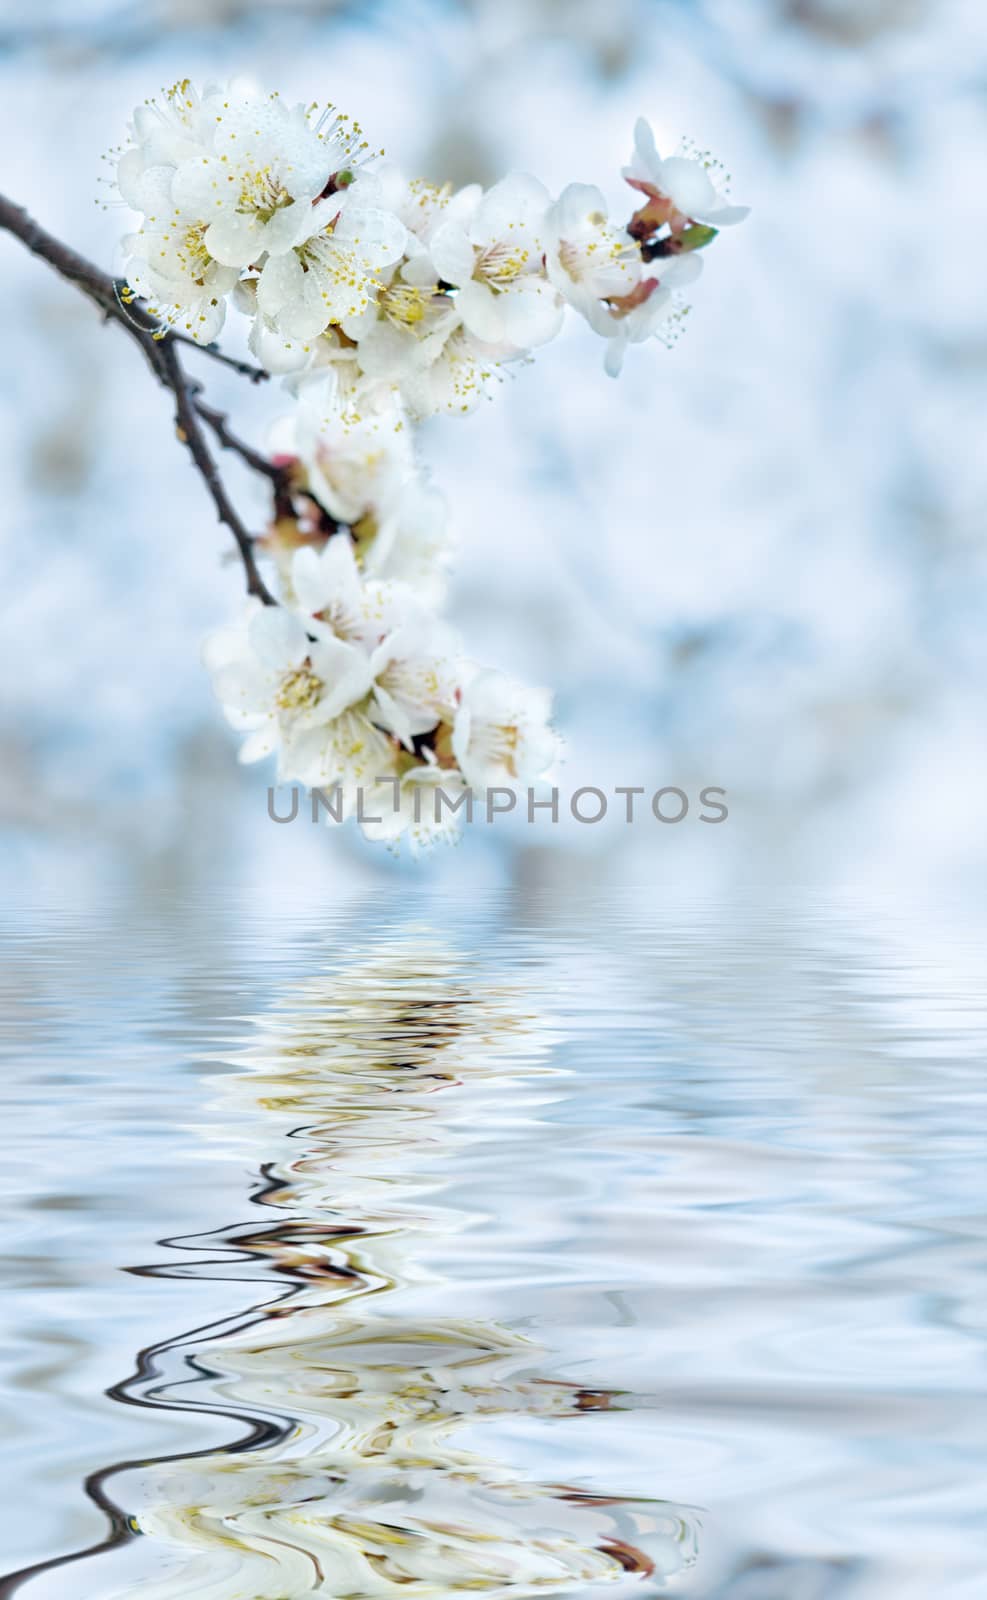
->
[117,82,745,850]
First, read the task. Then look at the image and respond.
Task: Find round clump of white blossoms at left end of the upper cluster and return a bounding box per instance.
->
[117,80,399,347]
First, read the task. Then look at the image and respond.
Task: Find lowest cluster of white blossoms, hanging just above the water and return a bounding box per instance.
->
[205,538,558,853]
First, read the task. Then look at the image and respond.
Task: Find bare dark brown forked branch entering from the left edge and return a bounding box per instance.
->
[0,195,280,605]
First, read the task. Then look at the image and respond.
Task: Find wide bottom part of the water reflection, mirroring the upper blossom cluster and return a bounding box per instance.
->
[132,1312,691,1600]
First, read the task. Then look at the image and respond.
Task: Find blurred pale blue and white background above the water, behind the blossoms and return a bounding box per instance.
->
[0,0,987,896]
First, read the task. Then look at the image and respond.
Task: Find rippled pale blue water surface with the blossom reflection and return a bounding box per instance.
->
[0,893,987,1600]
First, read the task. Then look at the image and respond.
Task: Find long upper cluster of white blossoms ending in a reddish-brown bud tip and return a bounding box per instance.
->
[117,82,747,396]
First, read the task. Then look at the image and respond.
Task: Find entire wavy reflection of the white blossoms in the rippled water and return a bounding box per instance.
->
[3,939,694,1600]
